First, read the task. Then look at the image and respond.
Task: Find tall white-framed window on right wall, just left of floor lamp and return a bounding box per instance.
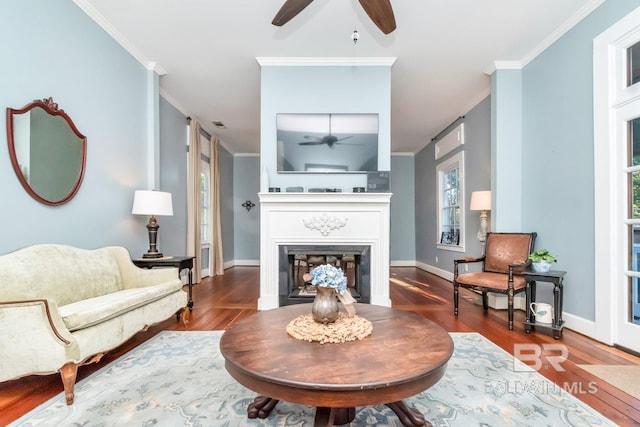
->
[437,151,464,252]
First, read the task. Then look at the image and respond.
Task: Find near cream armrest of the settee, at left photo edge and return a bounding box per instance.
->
[0,299,80,381]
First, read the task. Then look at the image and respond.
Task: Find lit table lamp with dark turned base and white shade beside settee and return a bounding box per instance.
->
[131,190,173,258]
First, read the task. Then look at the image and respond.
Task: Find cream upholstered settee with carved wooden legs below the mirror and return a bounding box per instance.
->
[0,244,188,405]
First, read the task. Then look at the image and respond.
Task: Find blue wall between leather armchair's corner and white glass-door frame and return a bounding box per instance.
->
[522,0,640,320]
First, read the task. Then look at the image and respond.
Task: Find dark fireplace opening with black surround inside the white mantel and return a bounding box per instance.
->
[278,245,371,306]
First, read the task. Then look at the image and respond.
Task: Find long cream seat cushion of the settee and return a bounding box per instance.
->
[59,279,182,332]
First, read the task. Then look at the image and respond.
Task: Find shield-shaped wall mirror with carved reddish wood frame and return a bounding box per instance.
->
[7,98,87,206]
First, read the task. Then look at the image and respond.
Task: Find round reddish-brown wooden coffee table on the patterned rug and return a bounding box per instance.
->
[220,304,453,426]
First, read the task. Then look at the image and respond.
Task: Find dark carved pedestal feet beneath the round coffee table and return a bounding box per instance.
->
[247,396,431,427]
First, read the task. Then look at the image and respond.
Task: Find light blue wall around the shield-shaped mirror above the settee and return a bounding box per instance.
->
[0,0,148,254]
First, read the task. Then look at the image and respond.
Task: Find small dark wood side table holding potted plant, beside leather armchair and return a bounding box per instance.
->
[524,270,567,339]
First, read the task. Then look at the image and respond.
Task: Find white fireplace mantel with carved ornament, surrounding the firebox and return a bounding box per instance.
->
[258,193,391,310]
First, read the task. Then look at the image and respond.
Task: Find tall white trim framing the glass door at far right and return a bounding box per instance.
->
[582,8,640,345]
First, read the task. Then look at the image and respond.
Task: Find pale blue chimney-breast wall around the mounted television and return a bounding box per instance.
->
[260,66,391,189]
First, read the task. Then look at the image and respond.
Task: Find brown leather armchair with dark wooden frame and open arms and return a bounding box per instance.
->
[453,233,537,330]
